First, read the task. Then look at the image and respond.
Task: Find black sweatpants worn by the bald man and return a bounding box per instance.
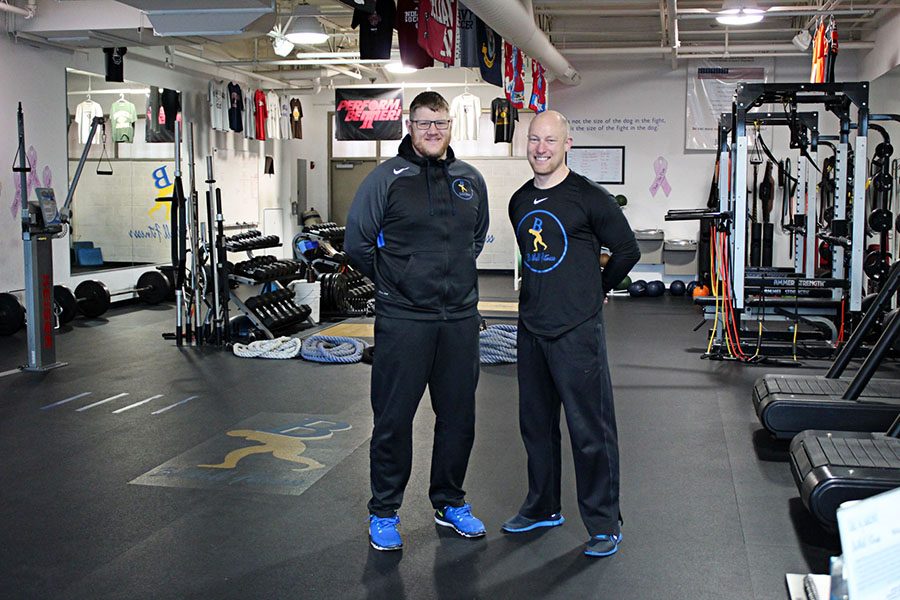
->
[517,313,619,536]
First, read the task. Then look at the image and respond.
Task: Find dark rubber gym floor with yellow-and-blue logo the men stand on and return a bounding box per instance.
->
[0,276,856,600]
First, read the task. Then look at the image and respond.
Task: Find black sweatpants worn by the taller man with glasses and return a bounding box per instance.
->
[369,316,480,517]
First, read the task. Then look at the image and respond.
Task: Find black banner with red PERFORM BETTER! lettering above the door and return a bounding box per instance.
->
[334,88,403,141]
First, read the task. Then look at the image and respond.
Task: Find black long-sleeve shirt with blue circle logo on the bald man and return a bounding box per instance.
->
[509,171,641,338]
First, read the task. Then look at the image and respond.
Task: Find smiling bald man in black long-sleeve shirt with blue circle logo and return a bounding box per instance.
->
[503,111,640,556]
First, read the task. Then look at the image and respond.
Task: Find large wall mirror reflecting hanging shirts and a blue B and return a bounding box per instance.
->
[66,69,181,275]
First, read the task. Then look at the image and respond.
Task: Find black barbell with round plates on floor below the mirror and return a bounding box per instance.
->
[53,271,172,323]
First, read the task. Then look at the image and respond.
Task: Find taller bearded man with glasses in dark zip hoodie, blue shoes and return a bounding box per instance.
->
[344,92,488,550]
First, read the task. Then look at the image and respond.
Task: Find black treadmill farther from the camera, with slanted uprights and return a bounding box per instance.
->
[753,261,900,439]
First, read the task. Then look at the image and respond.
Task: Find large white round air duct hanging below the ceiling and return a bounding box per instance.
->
[466,0,581,85]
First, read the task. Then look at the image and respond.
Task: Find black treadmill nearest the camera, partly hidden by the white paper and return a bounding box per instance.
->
[790,417,900,530]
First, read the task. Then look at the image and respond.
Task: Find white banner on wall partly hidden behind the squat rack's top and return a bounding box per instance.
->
[684,61,772,151]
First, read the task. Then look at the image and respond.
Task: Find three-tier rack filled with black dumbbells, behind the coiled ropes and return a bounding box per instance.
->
[225,230,312,339]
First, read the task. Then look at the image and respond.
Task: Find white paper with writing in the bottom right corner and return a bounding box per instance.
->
[837,488,900,600]
